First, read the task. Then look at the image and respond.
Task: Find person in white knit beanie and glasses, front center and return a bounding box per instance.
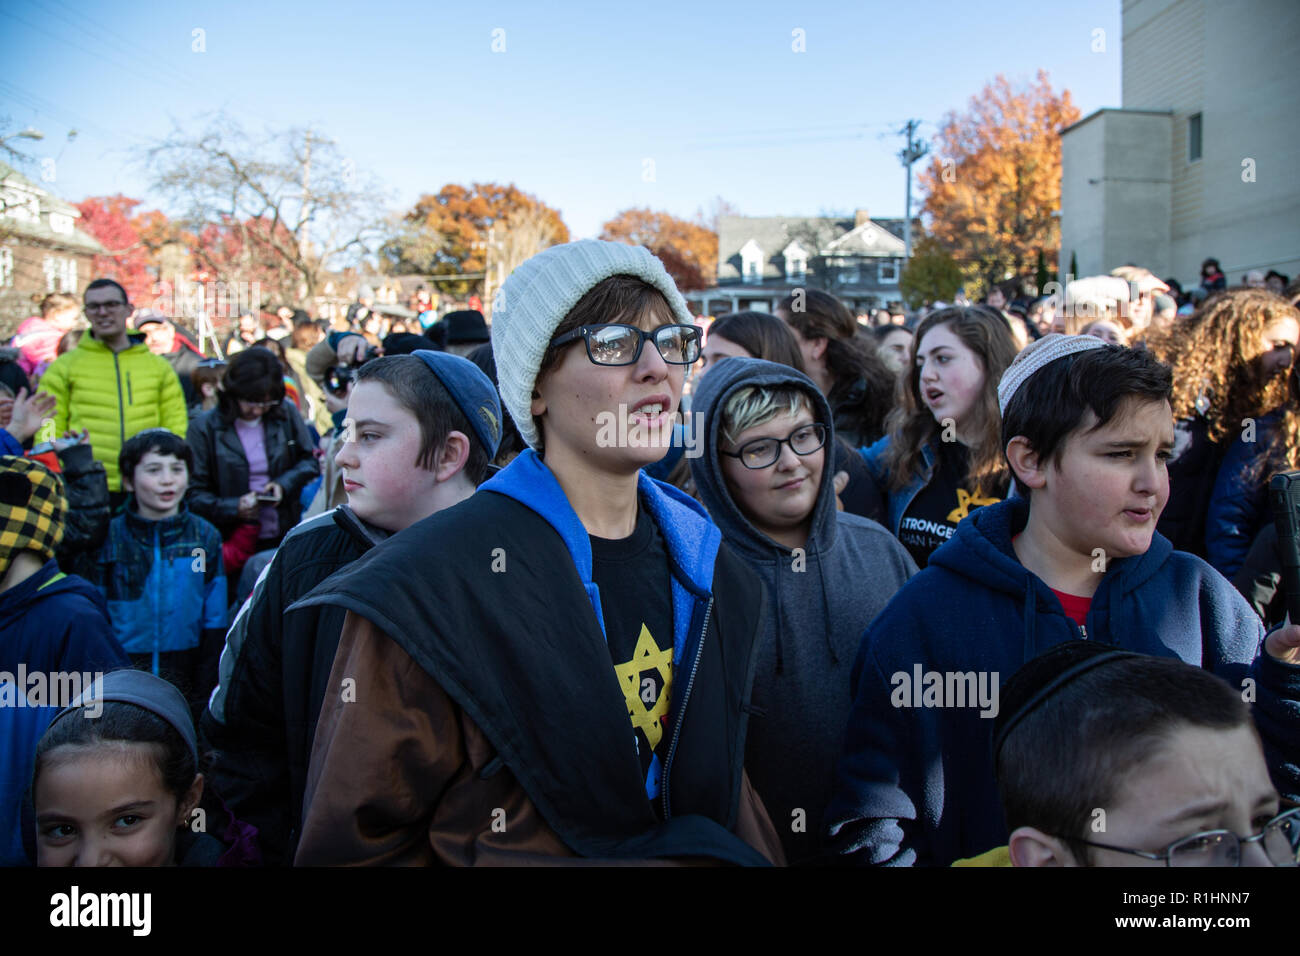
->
[298,241,784,864]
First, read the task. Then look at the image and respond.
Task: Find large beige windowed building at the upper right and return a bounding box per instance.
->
[1061,0,1300,286]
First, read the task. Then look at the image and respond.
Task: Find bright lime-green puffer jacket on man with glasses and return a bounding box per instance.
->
[38,332,190,492]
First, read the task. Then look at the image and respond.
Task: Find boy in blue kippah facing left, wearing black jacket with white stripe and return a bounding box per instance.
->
[202,350,502,864]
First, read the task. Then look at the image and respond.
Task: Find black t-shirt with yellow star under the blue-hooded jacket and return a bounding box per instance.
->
[592,509,672,790]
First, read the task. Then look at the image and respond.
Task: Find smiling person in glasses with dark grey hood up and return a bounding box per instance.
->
[690,358,917,864]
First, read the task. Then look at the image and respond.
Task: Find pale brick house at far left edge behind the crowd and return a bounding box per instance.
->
[0,163,108,341]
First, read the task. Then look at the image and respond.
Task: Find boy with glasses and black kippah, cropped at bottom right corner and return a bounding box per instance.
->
[977,641,1300,866]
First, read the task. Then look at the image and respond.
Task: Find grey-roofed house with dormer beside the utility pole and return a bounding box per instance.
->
[686,209,920,316]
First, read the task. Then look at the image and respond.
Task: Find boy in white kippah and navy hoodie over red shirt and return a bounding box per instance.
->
[827,336,1300,866]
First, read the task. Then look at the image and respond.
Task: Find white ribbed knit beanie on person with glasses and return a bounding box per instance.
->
[491,239,694,449]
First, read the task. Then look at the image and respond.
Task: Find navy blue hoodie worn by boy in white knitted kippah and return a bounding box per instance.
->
[827,498,1300,866]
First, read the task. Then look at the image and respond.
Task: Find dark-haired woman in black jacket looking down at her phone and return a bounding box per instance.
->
[187,347,320,550]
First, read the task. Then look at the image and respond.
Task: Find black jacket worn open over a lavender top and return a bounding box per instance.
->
[186,402,320,537]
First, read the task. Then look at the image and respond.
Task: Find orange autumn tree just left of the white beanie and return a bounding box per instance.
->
[380,182,569,294]
